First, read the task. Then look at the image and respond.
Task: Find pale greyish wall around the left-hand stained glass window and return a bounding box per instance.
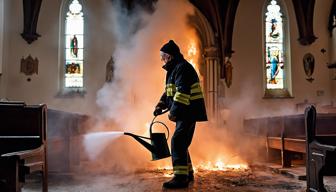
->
[4,0,114,114]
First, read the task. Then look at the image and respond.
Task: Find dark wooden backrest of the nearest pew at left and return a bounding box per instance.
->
[0,102,46,155]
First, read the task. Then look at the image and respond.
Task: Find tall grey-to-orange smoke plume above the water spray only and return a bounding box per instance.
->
[97,0,193,130]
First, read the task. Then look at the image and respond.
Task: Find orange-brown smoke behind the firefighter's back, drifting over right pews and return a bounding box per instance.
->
[213,77,302,163]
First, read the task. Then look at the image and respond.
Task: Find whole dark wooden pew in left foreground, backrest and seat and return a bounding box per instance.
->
[0,102,48,192]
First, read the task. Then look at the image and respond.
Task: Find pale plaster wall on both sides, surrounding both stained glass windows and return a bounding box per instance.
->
[0,0,333,119]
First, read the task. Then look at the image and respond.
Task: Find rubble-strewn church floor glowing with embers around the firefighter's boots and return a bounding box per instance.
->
[23,167,330,192]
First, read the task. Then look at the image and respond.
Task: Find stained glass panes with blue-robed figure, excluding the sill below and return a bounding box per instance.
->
[265,0,285,89]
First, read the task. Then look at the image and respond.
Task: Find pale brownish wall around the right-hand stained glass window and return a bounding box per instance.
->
[224,0,332,126]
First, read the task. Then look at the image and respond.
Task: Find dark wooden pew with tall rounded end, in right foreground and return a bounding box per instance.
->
[305,106,336,192]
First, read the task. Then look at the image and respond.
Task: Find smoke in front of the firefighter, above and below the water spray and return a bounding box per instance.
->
[85,0,196,172]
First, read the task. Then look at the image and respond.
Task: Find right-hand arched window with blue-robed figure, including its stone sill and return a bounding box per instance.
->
[263,0,291,98]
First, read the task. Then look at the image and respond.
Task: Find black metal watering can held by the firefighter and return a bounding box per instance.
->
[124,110,170,161]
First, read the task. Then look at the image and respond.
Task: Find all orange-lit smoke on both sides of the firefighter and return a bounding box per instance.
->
[80,0,334,176]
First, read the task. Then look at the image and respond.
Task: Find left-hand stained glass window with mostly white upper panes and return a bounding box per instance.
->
[64,0,84,88]
